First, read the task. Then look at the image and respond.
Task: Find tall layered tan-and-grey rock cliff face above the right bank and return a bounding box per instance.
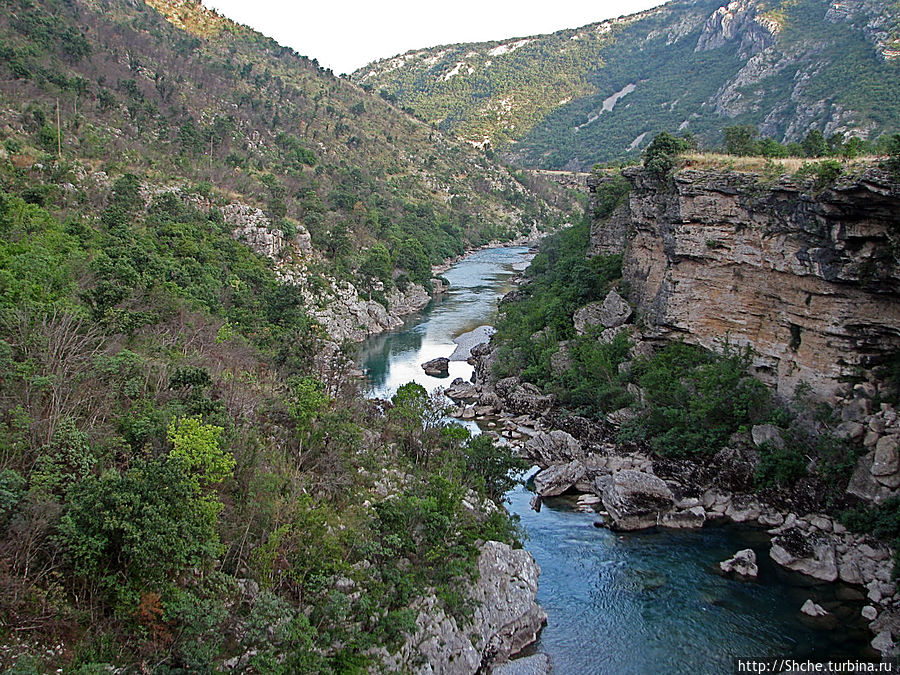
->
[588,169,900,399]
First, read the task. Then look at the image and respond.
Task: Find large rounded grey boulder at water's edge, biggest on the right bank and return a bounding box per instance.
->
[597,469,675,530]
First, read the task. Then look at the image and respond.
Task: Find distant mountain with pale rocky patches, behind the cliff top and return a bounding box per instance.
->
[352,0,900,169]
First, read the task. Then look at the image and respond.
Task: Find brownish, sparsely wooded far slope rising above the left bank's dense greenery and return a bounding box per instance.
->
[0,0,573,296]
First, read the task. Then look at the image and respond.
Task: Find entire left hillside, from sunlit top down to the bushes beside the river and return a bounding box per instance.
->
[0,0,572,673]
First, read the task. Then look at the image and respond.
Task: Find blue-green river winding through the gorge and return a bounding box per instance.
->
[359,247,868,675]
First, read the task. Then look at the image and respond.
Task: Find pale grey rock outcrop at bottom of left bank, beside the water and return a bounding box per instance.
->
[382,541,547,675]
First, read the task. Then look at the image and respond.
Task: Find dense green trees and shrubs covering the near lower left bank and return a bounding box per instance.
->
[0,185,517,673]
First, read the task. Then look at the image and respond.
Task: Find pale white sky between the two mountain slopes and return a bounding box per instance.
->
[204,0,662,75]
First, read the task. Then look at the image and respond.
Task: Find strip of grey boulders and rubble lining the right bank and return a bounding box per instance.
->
[446,316,900,658]
